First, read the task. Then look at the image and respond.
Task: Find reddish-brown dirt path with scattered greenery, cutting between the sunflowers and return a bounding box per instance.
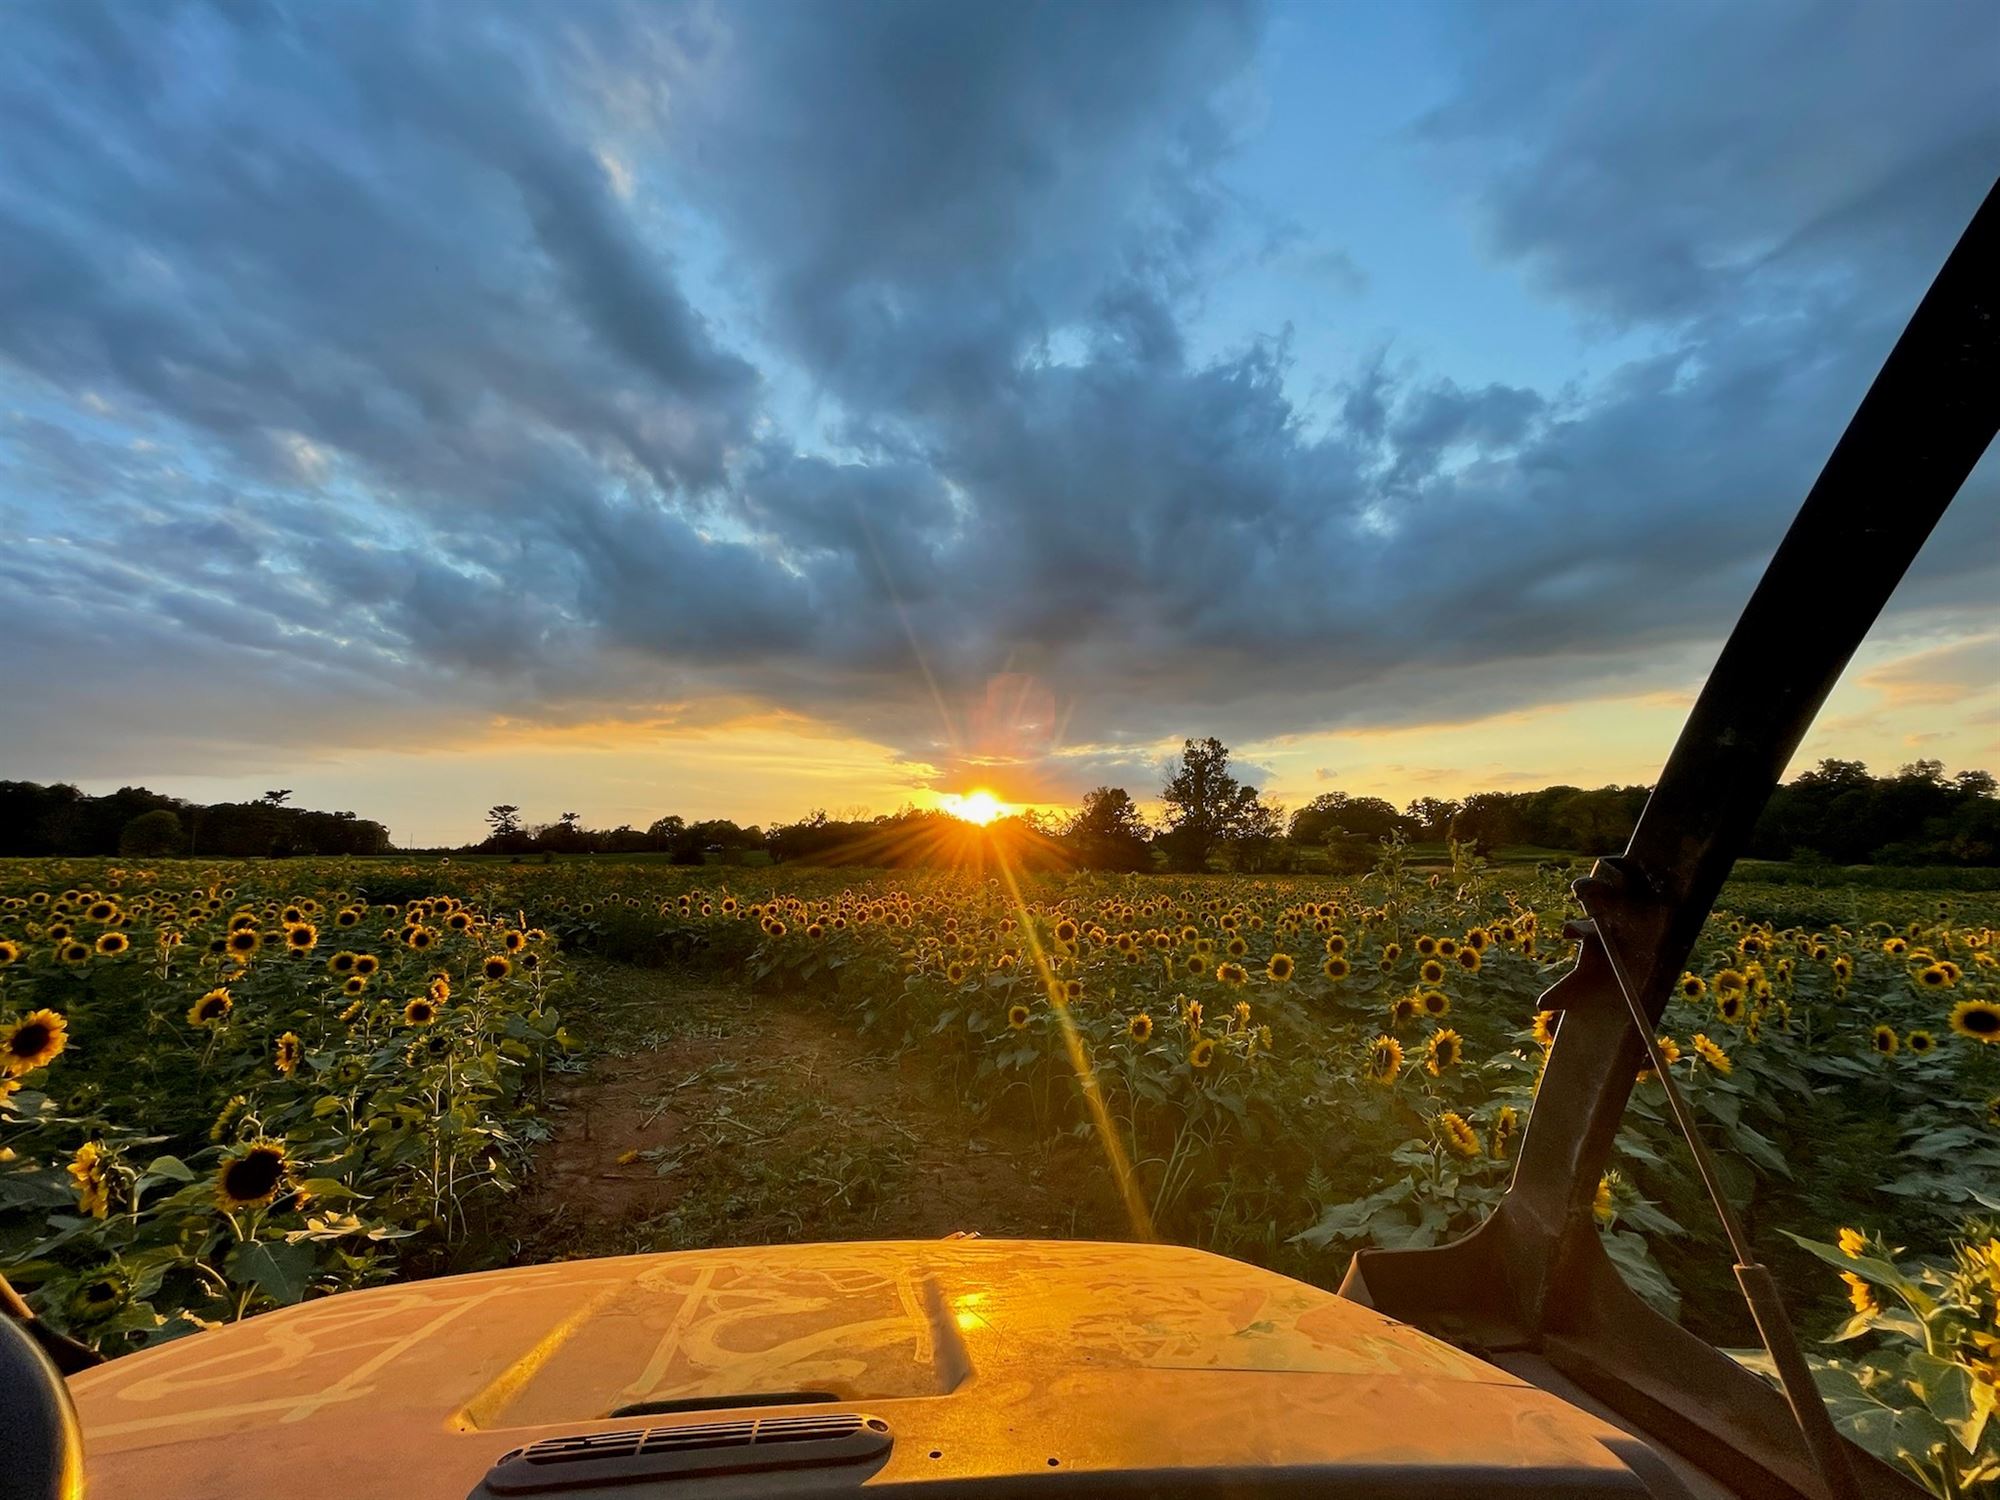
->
[520,964,1126,1260]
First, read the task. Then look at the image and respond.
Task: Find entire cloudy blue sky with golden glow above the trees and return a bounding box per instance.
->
[0,0,2000,844]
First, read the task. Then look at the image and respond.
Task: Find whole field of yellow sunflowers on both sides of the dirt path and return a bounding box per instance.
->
[0,850,2000,1492]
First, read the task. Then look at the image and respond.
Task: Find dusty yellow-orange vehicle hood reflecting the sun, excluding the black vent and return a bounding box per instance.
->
[72,1240,1642,1500]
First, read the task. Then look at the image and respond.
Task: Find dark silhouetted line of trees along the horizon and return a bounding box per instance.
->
[0,736,2000,874]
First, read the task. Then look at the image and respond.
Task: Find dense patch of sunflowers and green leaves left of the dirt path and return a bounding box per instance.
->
[0,864,566,1352]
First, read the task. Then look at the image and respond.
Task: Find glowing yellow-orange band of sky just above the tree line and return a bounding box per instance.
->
[50,634,2000,848]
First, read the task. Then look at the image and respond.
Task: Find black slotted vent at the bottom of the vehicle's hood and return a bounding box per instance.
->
[484,1412,892,1494]
